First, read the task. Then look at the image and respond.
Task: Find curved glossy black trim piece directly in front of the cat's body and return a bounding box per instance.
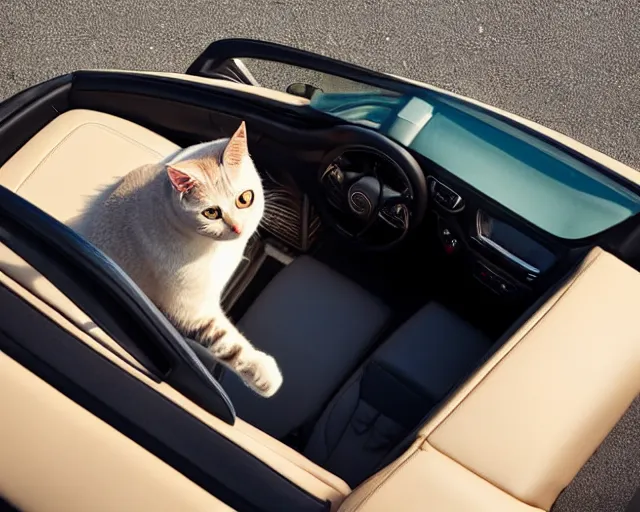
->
[0,186,235,423]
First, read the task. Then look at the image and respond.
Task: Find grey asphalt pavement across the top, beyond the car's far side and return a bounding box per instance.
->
[0,0,640,169]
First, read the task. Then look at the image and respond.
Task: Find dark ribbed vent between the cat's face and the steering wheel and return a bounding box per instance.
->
[261,167,321,251]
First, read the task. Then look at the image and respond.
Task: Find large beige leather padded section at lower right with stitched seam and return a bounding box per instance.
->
[341,248,640,512]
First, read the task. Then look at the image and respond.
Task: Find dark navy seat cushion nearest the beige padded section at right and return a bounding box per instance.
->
[304,303,491,487]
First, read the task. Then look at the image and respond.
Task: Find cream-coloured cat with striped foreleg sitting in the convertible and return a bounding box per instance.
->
[73,121,282,397]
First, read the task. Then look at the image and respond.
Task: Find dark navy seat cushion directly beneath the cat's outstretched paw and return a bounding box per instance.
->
[221,256,389,438]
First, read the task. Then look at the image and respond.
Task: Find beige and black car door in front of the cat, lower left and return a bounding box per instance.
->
[0,177,332,512]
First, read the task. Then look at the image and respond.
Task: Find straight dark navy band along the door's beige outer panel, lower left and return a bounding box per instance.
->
[0,287,335,512]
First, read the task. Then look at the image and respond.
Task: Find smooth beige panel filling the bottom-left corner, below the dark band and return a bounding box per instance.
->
[0,352,232,512]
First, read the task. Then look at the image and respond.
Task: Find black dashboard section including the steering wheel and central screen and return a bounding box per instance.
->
[255,120,569,300]
